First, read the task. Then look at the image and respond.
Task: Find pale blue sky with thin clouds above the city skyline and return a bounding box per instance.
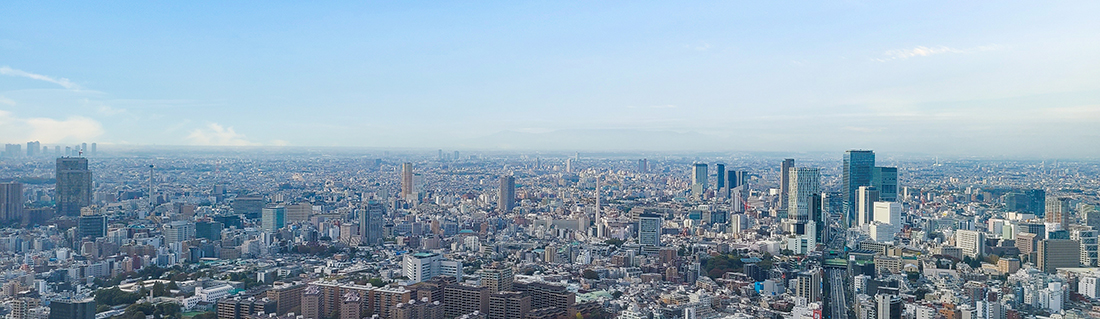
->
[0,1,1100,158]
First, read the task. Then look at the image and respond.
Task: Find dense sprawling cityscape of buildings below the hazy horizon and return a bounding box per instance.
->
[0,142,1100,319]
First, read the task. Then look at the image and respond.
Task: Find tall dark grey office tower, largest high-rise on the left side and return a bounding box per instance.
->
[54,157,91,216]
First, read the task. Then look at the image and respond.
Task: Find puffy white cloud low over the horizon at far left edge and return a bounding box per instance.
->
[0,111,103,143]
